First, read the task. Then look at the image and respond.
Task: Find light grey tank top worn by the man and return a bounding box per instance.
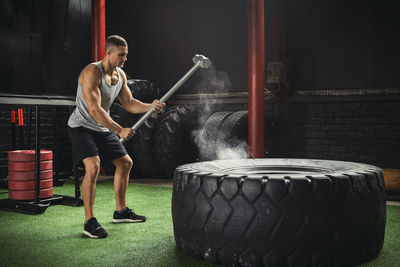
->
[68,61,123,132]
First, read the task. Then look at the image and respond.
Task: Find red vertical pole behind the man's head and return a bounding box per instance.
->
[92,0,106,61]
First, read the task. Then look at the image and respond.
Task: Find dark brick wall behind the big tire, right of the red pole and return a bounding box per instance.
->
[194,95,400,169]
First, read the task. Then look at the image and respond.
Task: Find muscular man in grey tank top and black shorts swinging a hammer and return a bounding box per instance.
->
[68,35,165,238]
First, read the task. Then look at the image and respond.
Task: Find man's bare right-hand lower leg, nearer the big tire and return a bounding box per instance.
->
[112,155,133,210]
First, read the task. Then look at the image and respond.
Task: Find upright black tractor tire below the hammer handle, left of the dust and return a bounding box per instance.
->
[154,105,199,178]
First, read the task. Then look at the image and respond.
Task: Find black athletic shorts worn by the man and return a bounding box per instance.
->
[67,126,128,162]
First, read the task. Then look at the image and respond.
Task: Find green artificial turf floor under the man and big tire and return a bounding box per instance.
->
[0,182,400,267]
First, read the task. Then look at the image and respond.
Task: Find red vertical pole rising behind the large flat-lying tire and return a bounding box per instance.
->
[247,0,265,158]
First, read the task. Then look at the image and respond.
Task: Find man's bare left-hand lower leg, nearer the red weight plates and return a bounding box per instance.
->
[82,156,100,221]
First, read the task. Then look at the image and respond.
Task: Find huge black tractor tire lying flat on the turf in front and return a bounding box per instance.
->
[172,159,386,266]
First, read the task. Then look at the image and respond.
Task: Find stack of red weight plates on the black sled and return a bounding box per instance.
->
[8,150,53,200]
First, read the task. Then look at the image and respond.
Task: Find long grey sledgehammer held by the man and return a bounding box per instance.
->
[119,55,211,143]
